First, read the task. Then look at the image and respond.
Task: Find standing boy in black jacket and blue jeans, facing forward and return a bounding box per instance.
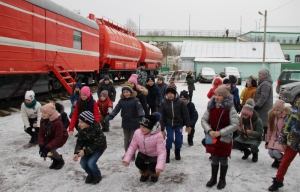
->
[159,85,191,163]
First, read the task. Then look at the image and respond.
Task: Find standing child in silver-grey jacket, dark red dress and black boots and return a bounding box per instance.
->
[201,85,239,189]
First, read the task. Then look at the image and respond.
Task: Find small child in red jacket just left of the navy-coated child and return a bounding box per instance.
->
[97,90,113,132]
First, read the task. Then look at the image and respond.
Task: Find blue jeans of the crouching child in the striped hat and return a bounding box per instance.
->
[80,151,103,177]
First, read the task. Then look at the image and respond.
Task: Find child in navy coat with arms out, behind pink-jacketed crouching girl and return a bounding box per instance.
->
[107,85,145,152]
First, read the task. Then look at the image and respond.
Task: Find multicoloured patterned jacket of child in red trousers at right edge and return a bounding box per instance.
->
[278,107,300,151]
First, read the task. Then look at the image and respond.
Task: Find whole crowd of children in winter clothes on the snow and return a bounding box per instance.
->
[21,70,300,191]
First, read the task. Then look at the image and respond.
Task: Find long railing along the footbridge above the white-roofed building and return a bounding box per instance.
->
[136,29,243,37]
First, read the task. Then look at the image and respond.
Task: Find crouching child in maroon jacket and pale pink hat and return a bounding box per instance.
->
[38,103,69,169]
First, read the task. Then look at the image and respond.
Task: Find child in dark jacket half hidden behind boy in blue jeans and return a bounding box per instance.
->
[180,90,198,146]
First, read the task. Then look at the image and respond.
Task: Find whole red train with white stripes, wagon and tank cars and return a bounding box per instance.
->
[0,0,162,100]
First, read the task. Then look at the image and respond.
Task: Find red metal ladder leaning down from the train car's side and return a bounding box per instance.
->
[49,64,76,94]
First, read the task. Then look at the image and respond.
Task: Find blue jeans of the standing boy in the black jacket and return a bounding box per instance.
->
[166,125,182,149]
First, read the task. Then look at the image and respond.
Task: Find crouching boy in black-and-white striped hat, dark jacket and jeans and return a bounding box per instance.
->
[73,111,107,184]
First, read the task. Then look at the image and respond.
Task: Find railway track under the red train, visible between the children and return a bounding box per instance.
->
[0,79,126,117]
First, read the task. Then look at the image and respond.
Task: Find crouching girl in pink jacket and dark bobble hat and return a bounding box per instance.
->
[123,112,166,182]
